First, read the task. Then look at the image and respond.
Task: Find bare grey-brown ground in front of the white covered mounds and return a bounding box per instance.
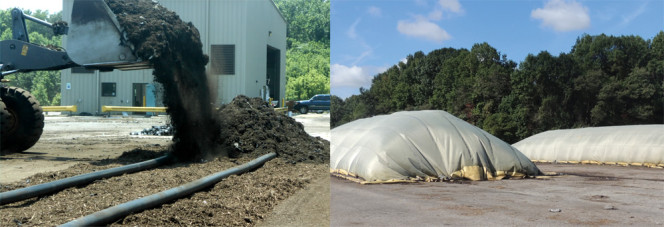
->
[330,164,664,226]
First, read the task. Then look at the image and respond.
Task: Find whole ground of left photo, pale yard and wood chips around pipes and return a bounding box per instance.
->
[0,114,329,226]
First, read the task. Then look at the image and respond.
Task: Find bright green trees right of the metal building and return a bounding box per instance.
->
[274,0,330,100]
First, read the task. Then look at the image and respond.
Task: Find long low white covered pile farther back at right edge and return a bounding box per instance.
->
[514,125,664,166]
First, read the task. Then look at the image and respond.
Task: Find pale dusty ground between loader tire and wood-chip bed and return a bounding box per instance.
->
[0,115,171,184]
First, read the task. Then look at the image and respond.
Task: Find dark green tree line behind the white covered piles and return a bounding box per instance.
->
[331,31,664,143]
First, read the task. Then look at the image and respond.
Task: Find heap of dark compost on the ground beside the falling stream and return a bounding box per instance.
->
[218,95,330,163]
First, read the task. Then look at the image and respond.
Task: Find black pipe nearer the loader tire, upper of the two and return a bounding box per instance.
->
[0,155,172,205]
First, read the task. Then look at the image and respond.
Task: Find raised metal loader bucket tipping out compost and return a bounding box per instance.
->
[66,0,150,70]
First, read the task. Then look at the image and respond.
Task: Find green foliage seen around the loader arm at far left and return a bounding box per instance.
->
[0,9,62,106]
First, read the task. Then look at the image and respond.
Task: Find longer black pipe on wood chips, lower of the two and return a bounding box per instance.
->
[61,152,277,227]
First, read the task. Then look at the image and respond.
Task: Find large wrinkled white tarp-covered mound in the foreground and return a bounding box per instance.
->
[330,110,540,182]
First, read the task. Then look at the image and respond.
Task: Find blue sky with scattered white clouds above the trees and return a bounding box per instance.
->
[330,0,664,98]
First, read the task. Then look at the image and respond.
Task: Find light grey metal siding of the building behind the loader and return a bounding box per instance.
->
[61,0,286,113]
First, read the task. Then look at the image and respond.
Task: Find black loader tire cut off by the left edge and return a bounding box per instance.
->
[0,87,44,154]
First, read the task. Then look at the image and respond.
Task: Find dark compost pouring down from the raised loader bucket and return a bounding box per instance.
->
[106,0,220,160]
